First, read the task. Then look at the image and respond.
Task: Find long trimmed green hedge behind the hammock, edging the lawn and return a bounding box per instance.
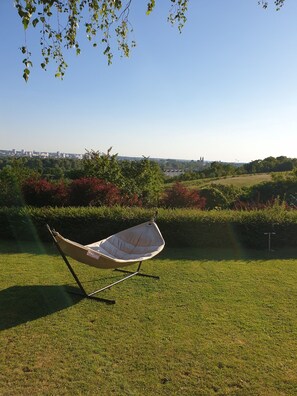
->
[0,207,297,248]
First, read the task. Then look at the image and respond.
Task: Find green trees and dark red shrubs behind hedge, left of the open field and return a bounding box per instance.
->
[0,149,163,207]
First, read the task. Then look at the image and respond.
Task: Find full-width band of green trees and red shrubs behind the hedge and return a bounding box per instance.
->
[0,149,297,210]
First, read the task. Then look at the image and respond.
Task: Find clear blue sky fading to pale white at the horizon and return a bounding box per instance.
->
[0,0,297,162]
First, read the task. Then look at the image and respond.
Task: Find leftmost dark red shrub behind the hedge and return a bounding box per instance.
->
[21,178,67,207]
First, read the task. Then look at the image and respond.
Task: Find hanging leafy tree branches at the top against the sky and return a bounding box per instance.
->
[15,0,285,81]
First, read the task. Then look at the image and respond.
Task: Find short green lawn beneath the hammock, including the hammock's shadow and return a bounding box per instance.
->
[0,242,297,396]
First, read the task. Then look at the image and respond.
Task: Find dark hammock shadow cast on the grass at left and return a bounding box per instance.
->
[0,285,82,330]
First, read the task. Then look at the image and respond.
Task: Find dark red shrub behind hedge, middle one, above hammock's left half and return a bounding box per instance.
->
[68,177,121,206]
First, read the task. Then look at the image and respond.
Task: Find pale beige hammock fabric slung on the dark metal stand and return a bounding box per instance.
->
[54,221,165,269]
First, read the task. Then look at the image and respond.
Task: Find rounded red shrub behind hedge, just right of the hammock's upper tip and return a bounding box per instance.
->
[162,182,206,209]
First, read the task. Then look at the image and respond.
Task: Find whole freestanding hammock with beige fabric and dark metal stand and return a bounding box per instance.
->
[46,220,165,304]
